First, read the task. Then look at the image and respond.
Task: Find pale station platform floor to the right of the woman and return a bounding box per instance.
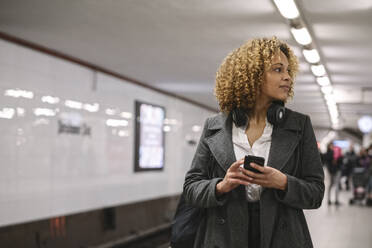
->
[305,170,372,248]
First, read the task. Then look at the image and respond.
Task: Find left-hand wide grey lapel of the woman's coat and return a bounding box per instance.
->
[205,114,236,171]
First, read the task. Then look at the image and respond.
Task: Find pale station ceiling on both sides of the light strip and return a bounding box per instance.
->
[0,0,372,130]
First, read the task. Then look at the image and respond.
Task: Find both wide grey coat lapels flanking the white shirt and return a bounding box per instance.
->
[205,109,301,171]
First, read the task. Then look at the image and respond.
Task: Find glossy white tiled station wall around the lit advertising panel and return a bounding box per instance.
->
[0,40,214,229]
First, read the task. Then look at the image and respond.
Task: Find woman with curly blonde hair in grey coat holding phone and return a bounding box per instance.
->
[184,37,324,248]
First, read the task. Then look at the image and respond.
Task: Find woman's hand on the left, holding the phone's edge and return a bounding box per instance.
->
[216,158,250,196]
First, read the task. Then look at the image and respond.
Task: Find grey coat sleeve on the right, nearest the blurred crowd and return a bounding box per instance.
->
[275,116,324,209]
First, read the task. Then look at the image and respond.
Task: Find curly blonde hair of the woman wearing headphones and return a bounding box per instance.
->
[214,37,298,112]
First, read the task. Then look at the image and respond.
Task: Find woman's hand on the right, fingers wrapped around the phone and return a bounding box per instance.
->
[241,163,287,190]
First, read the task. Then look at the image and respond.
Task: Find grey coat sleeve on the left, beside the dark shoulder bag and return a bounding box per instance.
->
[183,119,227,208]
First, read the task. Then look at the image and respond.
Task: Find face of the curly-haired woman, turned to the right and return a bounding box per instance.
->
[260,51,292,101]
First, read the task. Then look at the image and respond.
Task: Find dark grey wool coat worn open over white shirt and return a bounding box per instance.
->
[184,109,324,248]
